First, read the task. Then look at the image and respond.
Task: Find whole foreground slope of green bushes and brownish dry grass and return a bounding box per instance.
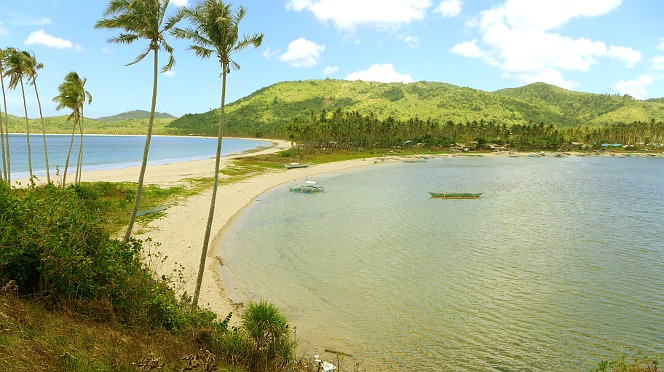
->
[0,182,297,371]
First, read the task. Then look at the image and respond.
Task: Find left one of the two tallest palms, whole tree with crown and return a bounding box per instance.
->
[95,0,182,241]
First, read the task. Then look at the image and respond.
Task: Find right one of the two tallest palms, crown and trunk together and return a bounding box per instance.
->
[172,0,263,307]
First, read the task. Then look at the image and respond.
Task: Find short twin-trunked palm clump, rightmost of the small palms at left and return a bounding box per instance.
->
[53,71,92,187]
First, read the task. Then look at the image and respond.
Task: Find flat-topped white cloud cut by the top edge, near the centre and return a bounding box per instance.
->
[286,0,432,31]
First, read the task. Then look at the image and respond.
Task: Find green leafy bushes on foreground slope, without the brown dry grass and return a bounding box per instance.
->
[0,181,296,371]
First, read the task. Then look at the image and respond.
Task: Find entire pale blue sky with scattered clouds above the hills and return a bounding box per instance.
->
[0,0,664,118]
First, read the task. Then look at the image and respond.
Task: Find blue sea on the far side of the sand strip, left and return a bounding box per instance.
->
[1,134,269,179]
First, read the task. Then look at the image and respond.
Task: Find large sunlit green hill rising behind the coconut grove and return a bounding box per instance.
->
[167,79,664,137]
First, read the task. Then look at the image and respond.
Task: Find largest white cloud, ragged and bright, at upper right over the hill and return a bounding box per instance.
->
[451,0,641,89]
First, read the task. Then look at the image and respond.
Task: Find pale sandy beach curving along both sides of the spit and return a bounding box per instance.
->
[12,147,661,319]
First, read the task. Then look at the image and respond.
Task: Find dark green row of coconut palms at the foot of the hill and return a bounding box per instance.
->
[285,109,664,152]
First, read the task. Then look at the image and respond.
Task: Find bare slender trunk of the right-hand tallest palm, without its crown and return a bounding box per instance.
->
[191,63,227,310]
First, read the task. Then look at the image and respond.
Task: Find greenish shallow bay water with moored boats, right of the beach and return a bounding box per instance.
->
[218,157,664,371]
